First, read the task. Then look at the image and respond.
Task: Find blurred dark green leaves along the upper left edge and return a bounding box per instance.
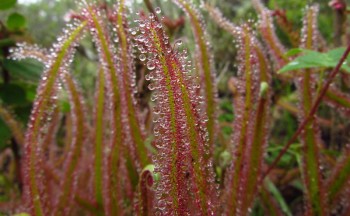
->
[0,0,27,150]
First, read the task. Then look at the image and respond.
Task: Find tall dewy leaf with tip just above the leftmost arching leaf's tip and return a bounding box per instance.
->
[83,3,125,215]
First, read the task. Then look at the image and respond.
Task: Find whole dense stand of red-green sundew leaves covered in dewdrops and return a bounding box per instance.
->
[0,0,350,216]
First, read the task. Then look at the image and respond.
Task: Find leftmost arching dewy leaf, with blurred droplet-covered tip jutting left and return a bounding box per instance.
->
[11,21,85,214]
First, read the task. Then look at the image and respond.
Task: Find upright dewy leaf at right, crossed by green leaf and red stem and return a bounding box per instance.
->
[296,5,328,216]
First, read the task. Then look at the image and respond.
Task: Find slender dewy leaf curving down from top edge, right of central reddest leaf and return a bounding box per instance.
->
[173,0,217,156]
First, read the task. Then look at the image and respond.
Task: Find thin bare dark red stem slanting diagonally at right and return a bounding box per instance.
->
[259,44,350,182]
